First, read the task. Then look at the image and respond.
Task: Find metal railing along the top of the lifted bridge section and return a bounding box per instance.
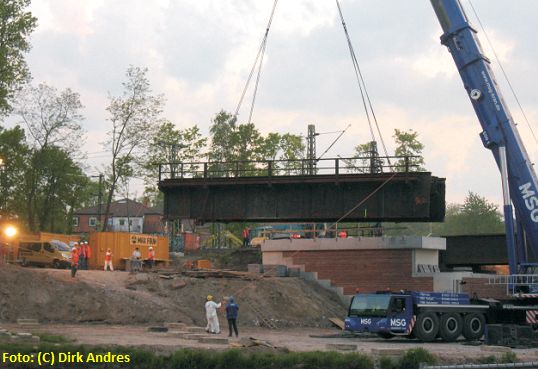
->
[159,156,418,181]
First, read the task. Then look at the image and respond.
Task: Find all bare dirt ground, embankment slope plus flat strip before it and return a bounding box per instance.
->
[0,265,538,362]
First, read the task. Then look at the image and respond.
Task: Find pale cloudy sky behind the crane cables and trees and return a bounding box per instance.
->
[5,0,538,204]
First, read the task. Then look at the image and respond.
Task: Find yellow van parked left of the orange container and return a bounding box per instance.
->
[18,240,71,268]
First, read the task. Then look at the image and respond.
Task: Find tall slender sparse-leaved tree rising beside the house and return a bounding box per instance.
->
[102,66,164,231]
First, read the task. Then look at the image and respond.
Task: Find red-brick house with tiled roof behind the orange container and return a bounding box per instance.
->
[73,199,164,234]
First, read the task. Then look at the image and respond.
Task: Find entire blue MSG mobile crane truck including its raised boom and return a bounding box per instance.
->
[345,0,538,341]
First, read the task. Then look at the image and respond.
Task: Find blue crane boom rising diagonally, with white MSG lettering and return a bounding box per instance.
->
[431,0,538,274]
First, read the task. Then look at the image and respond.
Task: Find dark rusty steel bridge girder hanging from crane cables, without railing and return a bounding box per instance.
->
[159,172,445,222]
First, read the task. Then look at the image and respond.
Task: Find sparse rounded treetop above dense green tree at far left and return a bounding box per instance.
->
[15,83,84,154]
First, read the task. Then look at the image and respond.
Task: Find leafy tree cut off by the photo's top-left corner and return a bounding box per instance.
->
[0,0,37,116]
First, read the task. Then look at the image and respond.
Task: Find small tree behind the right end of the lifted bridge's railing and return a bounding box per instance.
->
[393,129,425,172]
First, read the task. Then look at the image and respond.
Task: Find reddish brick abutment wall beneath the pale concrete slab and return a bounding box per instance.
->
[283,249,433,294]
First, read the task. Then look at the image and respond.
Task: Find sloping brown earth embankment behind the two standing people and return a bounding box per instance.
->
[0,265,346,328]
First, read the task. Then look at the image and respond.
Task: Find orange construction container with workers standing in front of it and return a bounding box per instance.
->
[88,232,169,270]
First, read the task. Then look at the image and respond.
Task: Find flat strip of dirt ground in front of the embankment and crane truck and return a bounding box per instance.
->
[1,319,538,363]
